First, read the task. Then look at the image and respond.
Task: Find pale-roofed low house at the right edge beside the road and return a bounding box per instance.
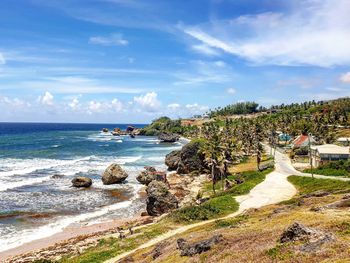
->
[311,144,350,167]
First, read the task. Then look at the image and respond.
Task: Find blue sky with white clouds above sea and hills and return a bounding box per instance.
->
[0,0,350,123]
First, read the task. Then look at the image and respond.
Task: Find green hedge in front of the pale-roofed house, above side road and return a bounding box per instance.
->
[304,160,350,177]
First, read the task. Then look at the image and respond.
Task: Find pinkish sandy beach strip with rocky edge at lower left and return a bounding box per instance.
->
[0,137,190,262]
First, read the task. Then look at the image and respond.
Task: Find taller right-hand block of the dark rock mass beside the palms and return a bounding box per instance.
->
[177,141,206,174]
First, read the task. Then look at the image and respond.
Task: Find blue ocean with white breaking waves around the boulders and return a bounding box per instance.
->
[0,123,181,251]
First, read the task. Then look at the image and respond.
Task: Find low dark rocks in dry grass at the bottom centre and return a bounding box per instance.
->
[177,235,223,257]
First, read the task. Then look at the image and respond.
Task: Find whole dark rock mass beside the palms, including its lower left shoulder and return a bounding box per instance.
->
[165,141,207,174]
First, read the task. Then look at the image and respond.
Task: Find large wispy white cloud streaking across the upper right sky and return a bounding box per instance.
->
[183,0,350,67]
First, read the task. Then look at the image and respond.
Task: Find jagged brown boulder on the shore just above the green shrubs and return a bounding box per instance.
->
[146,180,178,216]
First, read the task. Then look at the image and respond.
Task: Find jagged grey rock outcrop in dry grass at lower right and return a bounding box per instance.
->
[279,222,334,252]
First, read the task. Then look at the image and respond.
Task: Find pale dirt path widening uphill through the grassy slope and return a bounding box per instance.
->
[105,148,297,263]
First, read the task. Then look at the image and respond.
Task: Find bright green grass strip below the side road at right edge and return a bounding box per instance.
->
[288,175,350,195]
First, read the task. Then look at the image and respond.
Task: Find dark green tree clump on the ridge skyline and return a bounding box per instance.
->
[209,102,262,118]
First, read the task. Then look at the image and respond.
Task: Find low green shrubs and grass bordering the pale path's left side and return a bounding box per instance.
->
[169,195,239,224]
